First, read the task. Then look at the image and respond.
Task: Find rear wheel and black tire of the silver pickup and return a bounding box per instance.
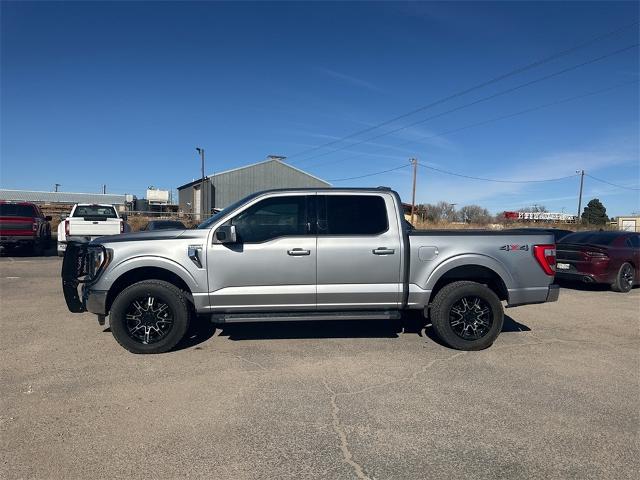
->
[430,281,504,350]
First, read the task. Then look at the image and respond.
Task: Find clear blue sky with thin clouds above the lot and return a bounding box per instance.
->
[0,2,640,215]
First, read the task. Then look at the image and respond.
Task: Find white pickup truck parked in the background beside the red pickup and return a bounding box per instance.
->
[58,203,125,257]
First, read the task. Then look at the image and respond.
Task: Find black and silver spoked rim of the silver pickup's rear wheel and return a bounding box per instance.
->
[449,296,493,340]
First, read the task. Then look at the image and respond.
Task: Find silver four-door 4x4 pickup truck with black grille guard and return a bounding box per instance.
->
[62,187,559,353]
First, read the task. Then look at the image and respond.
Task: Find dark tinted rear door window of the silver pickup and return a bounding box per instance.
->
[318,195,389,235]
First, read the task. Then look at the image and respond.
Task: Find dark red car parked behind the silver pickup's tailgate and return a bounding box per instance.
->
[556,232,640,292]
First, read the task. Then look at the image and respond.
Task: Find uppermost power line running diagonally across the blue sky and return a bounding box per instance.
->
[288,22,640,159]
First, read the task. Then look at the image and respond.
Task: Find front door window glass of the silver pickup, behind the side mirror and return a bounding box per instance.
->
[231,196,309,243]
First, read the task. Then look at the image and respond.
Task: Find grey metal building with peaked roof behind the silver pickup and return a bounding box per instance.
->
[178,156,331,216]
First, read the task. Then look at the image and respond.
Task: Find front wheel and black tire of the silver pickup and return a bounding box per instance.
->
[109,280,191,353]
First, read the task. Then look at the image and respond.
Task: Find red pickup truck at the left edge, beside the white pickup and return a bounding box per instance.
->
[0,201,51,255]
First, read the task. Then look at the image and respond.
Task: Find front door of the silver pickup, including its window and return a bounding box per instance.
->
[207,194,317,312]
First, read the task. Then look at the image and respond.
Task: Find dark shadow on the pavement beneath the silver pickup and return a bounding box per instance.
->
[174,315,531,350]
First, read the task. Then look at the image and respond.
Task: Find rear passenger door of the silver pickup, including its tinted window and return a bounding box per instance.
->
[317,192,402,310]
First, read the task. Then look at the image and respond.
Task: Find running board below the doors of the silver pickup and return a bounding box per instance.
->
[211,310,400,323]
